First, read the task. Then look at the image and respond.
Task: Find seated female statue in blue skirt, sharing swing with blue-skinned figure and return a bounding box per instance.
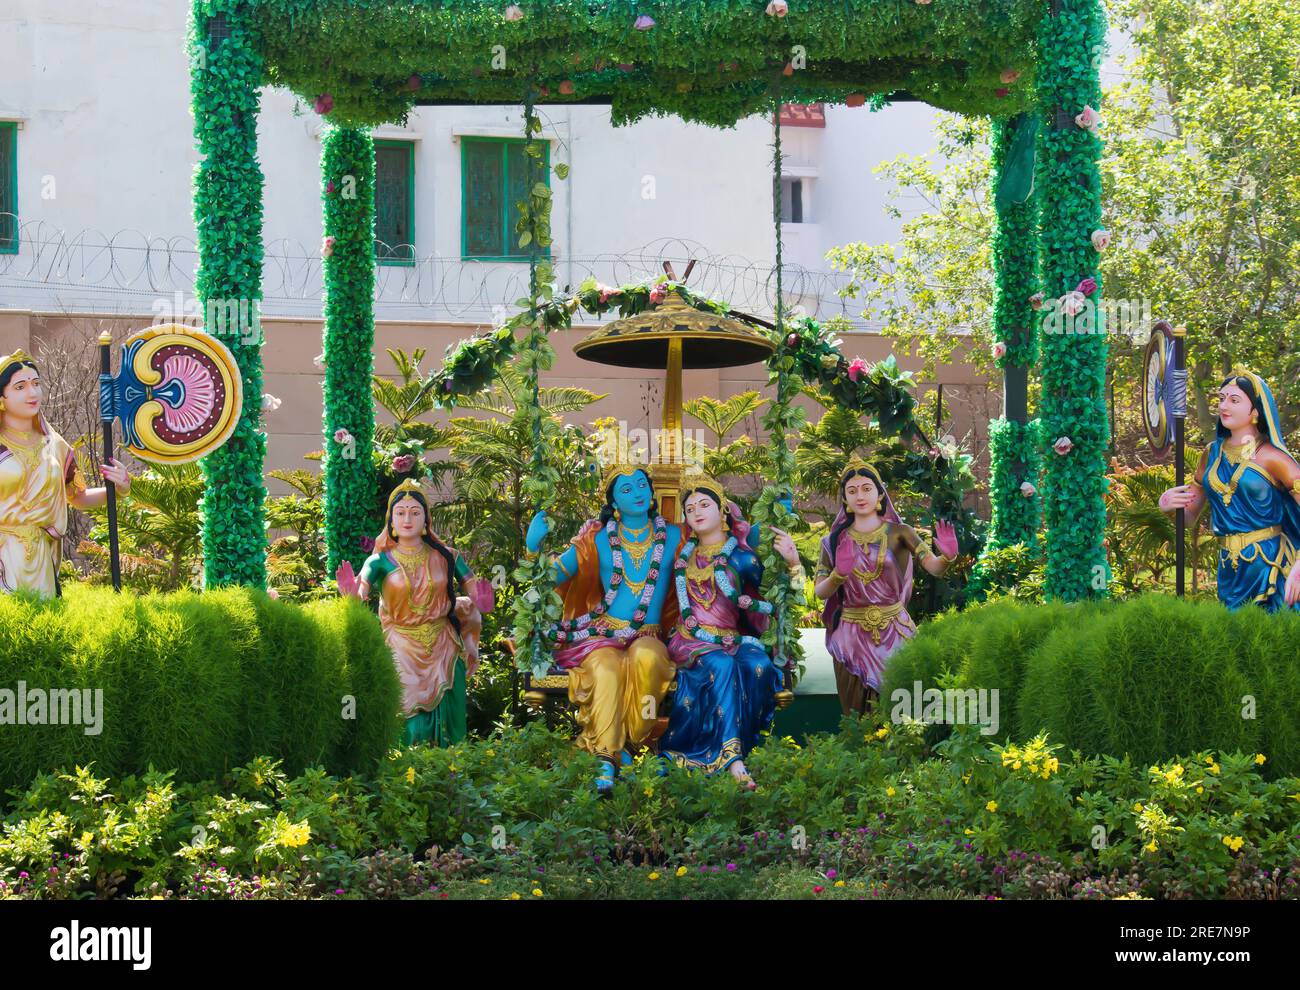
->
[659,473,802,790]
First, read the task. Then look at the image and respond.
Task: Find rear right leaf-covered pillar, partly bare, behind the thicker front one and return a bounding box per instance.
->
[985,114,1043,550]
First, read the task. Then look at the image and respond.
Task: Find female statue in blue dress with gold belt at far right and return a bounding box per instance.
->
[1160,369,1300,612]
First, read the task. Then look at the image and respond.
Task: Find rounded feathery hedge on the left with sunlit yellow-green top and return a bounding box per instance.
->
[0,585,400,789]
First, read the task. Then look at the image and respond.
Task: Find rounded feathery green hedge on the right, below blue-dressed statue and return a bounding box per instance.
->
[881,594,1300,774]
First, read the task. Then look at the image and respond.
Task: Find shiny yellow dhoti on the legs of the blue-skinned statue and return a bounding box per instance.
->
[569,635,673,760]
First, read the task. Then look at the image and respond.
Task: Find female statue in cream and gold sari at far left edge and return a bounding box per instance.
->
[0,351,131,598]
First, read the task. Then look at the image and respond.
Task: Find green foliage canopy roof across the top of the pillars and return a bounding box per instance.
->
[254,0,1044,127]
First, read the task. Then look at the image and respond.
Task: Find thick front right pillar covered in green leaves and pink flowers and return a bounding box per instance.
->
[1036,0,1110,602]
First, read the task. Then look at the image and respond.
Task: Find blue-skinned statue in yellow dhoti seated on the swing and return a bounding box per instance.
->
[525,464,681,793]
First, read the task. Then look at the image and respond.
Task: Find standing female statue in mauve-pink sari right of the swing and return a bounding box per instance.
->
[814,457,957,715]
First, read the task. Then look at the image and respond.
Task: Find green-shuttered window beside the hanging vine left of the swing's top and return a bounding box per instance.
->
[460,138,551,261]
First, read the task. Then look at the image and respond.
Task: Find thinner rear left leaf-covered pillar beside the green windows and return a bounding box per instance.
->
[321,126,380,574]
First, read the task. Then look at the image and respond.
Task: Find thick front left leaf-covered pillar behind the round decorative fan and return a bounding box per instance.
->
[189,0,267,587]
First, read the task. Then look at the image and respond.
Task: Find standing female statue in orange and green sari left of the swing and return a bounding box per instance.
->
[337,479,495,746]
